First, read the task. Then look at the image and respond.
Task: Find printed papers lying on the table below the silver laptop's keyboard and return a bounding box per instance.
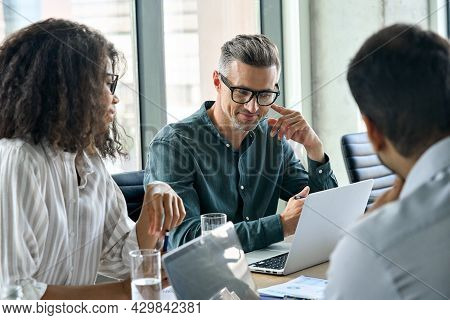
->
[258,276,327,300]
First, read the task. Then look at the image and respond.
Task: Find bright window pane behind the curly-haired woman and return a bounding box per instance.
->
[0,0,141,173]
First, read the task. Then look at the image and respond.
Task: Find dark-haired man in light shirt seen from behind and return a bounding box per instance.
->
[326,25,450,299]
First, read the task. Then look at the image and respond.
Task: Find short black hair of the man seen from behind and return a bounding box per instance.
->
[347,24,450,157]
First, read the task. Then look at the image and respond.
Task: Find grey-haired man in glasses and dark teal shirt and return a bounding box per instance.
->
[144,35,337,252]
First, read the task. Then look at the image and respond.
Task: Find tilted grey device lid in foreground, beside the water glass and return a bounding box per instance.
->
[163,222,259,300]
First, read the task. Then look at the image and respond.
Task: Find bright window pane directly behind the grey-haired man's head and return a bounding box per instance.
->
[163,0,260,123]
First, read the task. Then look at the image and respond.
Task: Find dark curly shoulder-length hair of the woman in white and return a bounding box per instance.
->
[0,19,126,158]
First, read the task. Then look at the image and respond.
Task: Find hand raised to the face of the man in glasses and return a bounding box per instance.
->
[268,104,325,162]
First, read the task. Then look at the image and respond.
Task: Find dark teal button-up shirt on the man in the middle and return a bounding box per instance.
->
[144,101,337,252]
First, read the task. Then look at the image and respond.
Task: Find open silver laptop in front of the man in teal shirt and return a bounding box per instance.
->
[246,180,373,275]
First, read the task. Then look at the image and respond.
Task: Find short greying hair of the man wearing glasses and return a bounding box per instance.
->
[219,34,280,76]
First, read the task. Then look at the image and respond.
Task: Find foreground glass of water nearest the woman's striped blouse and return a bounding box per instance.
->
[130,249,161,300]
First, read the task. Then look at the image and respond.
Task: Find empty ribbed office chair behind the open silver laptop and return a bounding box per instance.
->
[341,132,395,207]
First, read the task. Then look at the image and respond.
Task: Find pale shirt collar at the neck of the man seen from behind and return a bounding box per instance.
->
[400,137,450,199]
